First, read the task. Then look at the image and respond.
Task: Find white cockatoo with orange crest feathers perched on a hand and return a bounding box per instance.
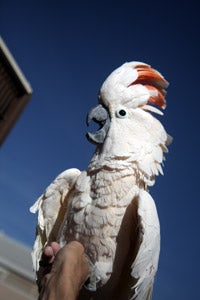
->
[31,62,170,300]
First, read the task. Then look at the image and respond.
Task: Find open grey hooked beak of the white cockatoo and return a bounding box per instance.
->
[86,104,110,145]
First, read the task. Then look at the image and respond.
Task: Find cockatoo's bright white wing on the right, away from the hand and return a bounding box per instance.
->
[131,190,160,300]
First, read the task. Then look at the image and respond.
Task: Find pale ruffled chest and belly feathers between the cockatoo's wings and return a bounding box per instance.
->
[57,169,138,285]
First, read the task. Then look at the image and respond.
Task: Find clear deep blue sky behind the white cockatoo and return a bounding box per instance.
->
[0,0,200,300]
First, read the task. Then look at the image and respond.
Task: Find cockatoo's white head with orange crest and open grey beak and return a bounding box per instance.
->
[87,62,168,176]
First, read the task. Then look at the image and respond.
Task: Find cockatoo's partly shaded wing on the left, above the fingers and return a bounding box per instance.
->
[30,169,81,272]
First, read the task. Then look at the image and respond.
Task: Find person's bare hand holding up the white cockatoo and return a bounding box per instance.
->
[38,241,89,300]
